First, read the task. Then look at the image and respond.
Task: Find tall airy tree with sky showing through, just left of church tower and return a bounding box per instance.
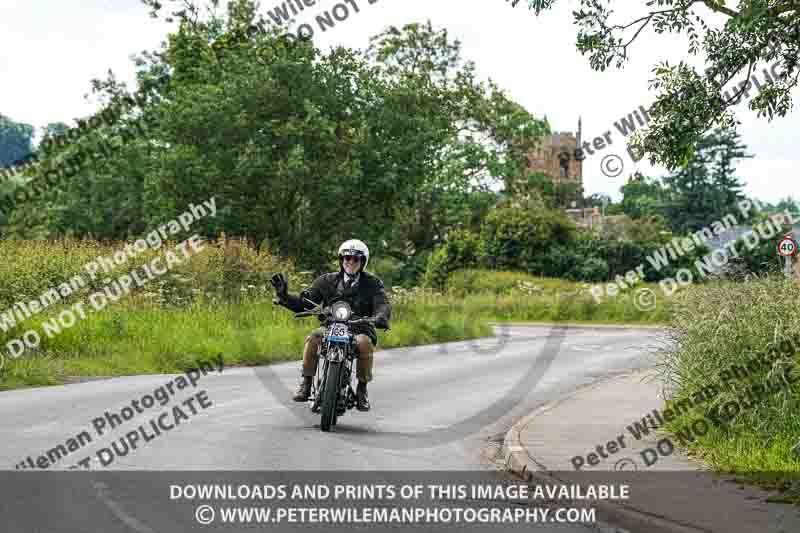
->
[367,21,547,258]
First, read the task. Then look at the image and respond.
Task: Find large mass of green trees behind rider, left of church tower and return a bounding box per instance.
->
[1,6,545,283]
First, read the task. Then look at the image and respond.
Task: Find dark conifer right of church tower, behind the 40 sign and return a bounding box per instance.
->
[664,129,751,233]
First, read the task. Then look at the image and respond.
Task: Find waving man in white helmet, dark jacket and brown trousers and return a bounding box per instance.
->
[271,239,391,411]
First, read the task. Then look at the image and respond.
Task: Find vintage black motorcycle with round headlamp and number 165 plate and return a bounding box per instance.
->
[294,300,389,432]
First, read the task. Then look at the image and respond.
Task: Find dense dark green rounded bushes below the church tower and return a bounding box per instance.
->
[423,206,708,288]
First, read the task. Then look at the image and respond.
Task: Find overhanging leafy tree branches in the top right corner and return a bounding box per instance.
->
[512,0,800,170]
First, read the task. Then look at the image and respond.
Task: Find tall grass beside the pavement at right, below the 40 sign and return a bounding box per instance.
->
[662,276,800,501]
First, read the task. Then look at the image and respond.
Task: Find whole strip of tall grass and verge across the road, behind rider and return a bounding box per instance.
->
[0,238,668,389]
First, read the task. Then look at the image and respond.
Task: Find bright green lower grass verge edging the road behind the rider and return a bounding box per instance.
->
[0,275,667,390]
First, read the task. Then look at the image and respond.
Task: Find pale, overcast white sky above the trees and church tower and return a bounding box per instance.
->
[0,0,800,203]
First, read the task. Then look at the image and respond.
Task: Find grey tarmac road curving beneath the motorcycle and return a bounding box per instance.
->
[0,326,662,533]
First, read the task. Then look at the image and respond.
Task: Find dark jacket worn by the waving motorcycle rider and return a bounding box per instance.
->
[283,271,392,345]
